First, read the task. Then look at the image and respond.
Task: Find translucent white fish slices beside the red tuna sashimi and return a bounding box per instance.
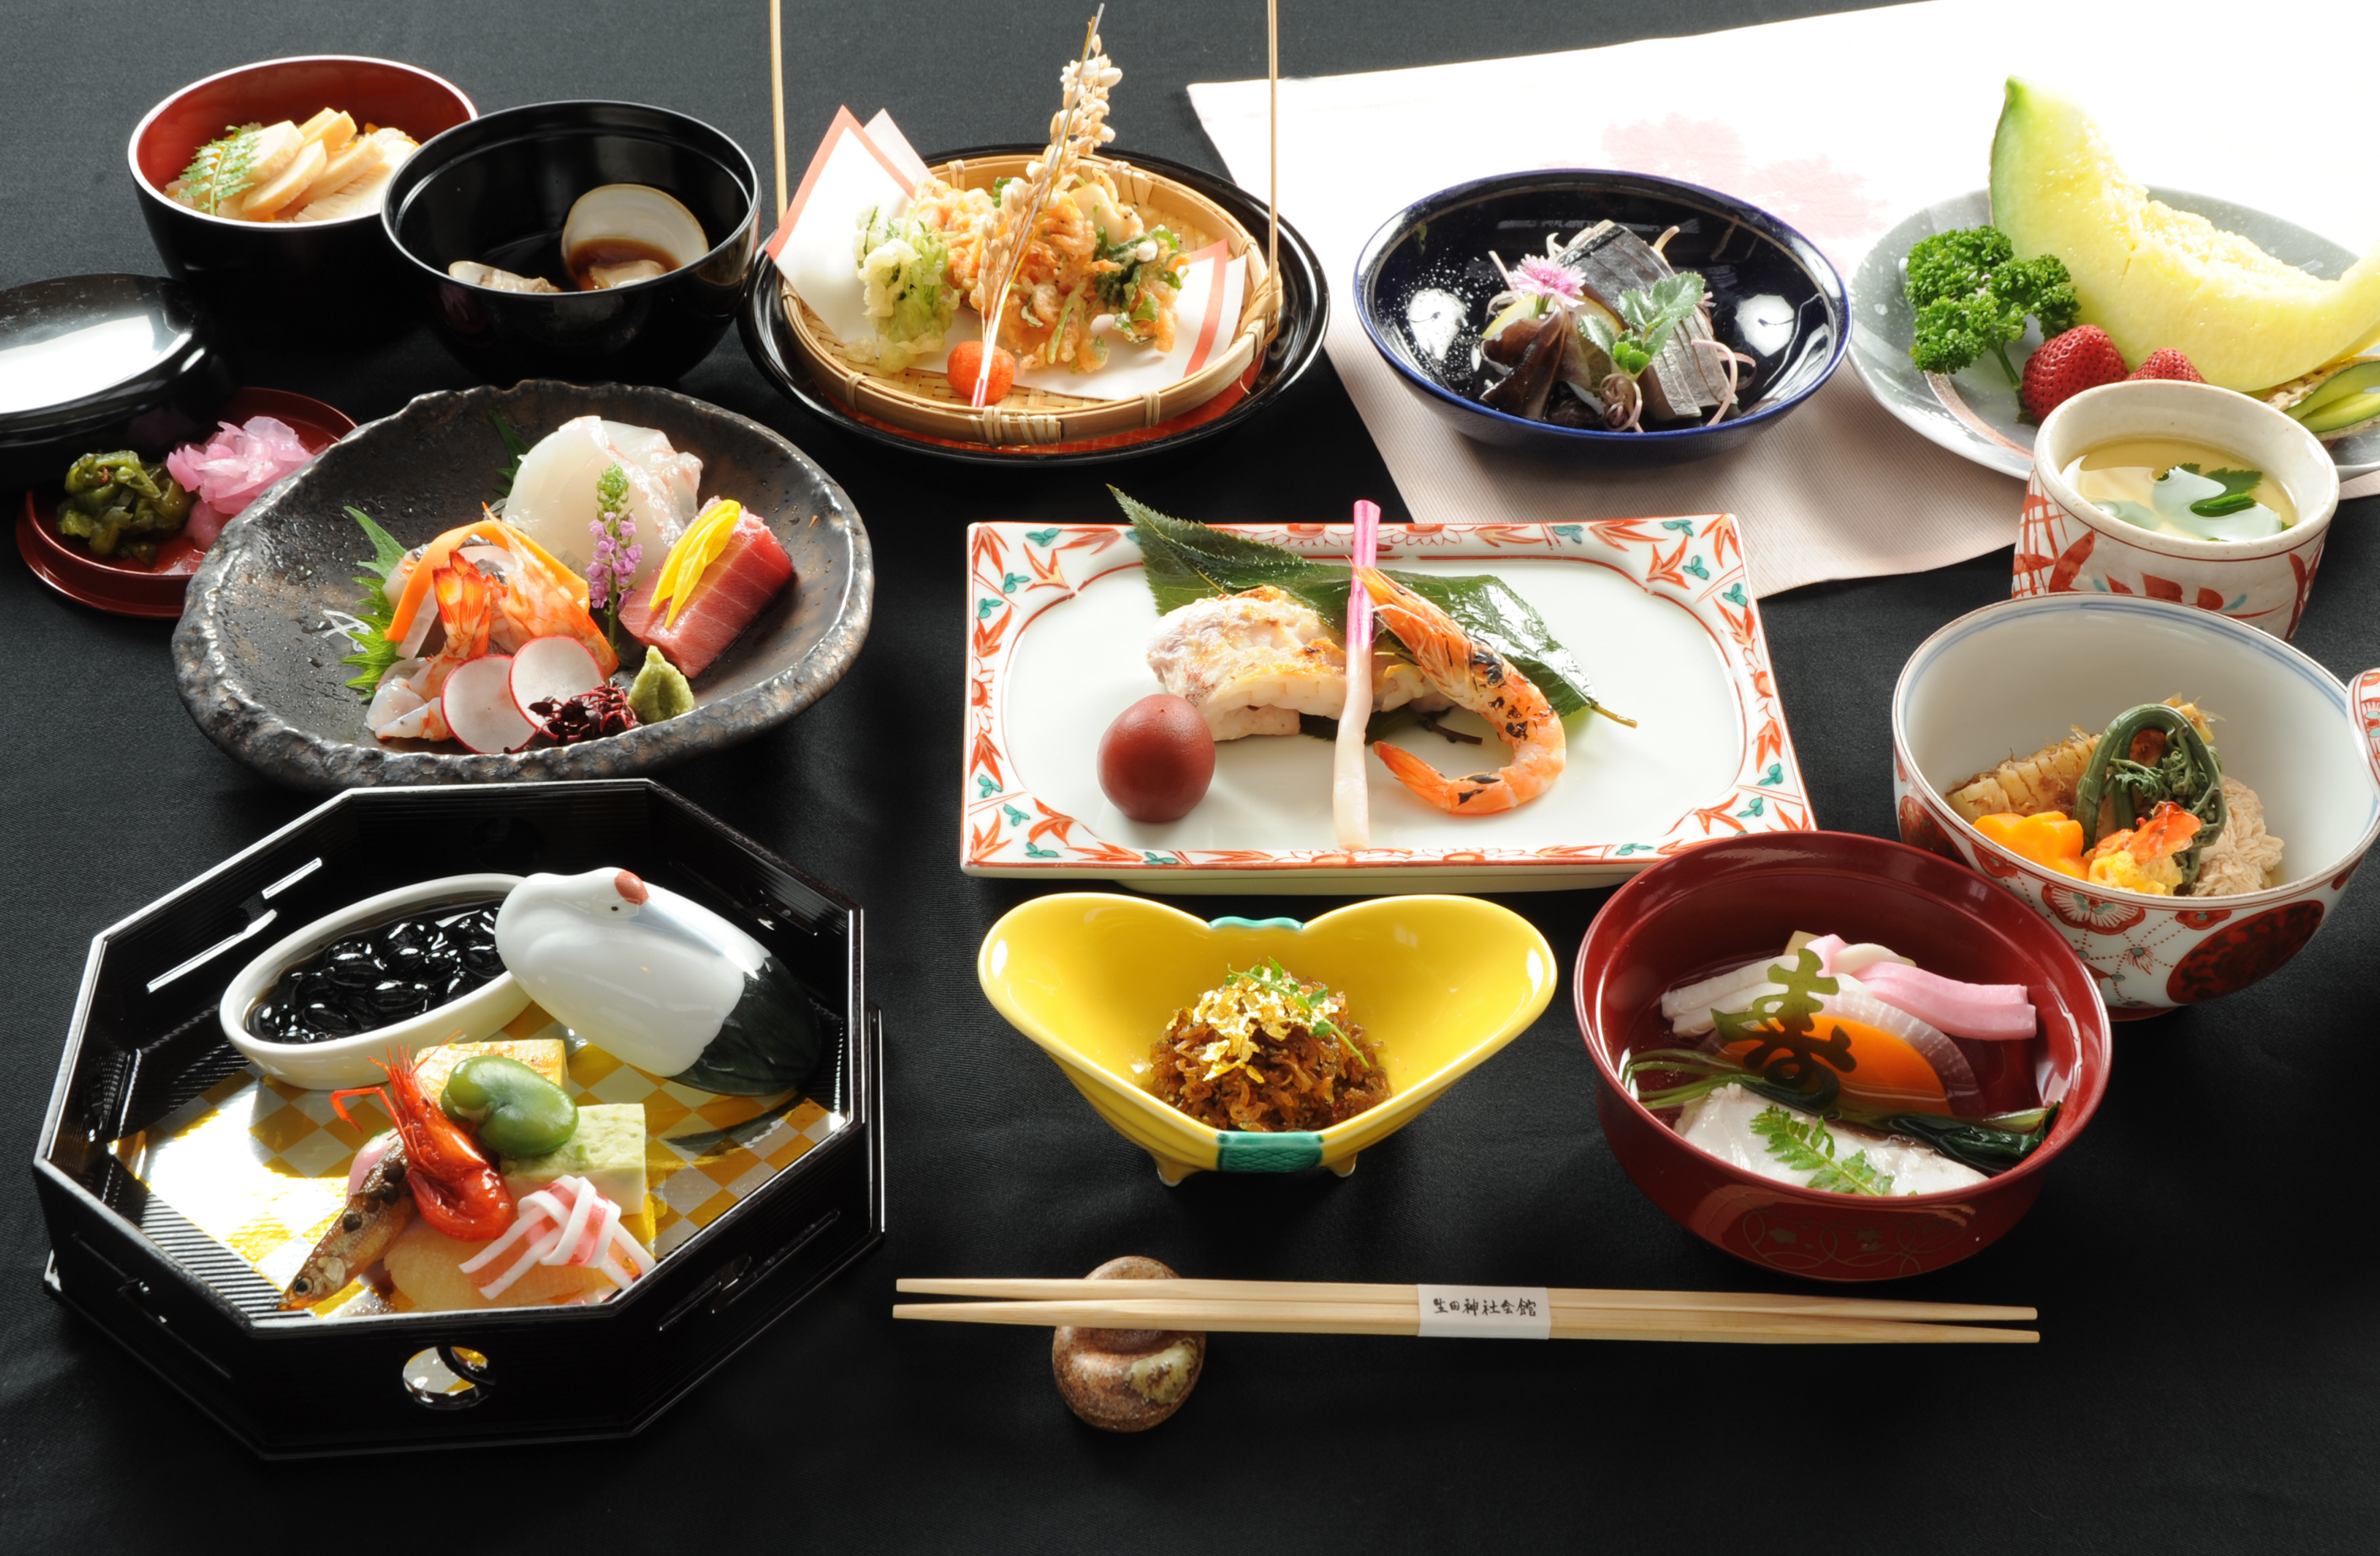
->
[505,416,702,583]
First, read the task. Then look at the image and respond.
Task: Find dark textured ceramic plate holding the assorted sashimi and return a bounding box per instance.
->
[174,380,876,790]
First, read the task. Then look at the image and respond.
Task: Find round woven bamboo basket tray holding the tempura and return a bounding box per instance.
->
[778,153,1280,447]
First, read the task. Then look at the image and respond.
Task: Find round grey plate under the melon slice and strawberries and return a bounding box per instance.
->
[1851,188,2380,480]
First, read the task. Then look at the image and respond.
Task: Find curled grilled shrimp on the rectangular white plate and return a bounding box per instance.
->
[1356,566,1564,816]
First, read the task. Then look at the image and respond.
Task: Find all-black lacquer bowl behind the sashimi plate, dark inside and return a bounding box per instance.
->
[381,102,759,383]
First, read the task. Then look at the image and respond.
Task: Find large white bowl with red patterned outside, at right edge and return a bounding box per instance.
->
[1892,593,2380,1018]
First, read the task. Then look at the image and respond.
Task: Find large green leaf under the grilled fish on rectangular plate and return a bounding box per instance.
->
[1107,487,1635,723]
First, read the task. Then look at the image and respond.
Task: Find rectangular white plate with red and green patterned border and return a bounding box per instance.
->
[959,514,1816,892]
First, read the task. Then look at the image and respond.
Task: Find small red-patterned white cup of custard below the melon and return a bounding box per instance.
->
[2009,378,2340,638]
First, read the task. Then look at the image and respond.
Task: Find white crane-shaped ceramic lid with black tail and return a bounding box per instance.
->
[495,869,828,1096]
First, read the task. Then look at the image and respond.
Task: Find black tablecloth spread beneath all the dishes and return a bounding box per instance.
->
[0,0,2380,1551]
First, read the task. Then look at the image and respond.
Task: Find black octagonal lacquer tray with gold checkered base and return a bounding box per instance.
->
[33,778,885,1458]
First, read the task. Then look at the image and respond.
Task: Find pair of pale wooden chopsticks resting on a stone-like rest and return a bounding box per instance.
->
[895,1275,2040,1332]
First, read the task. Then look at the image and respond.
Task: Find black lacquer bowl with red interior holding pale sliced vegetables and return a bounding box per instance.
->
[124,55,478,352]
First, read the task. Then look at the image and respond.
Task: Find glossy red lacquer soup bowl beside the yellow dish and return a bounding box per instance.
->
[1573,833,2109,1280]
